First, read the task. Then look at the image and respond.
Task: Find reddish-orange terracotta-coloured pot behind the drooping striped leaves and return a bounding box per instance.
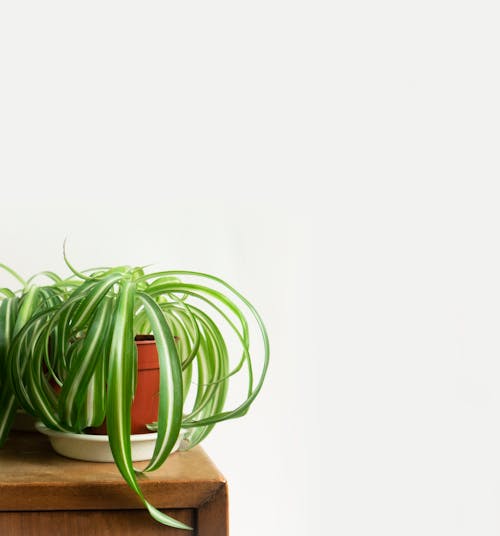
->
[88,335,160,435]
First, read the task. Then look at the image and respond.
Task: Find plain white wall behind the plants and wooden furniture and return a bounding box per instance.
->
[0,0,500,536]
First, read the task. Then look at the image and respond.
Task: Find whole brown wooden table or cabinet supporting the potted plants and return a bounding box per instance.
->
[0,432,229,536]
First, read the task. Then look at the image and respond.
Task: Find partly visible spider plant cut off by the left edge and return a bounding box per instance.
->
[0,264,71,447]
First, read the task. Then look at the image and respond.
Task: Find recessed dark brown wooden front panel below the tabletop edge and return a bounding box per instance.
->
[0,509,196,536]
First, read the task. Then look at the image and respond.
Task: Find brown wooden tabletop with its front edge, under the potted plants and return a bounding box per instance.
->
[0,432,226,511]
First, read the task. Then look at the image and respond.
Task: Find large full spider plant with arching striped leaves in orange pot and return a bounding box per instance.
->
[6,256,269,529]
